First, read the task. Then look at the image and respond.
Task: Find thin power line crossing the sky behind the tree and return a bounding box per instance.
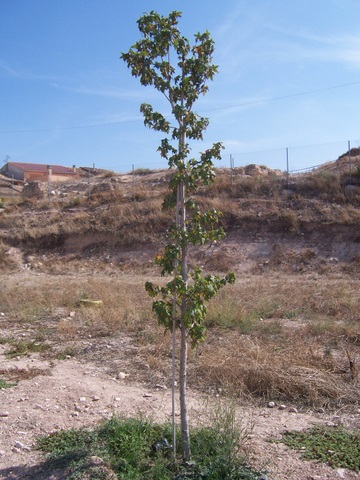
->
[0,80,360,134]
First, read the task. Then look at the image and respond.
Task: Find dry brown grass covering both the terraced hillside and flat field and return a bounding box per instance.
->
[0,169,360,405]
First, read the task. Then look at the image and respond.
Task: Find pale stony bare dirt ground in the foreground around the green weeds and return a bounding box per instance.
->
[0,346,360,480]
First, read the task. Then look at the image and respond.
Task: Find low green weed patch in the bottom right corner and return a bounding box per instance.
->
[281,426,360,473]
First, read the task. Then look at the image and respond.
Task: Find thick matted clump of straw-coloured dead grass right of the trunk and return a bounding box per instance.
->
[192,337,357,405]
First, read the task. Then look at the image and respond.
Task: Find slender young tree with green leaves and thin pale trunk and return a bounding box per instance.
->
[121,11,235,462]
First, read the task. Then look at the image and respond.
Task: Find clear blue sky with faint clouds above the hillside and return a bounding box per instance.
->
[0,0,360,172]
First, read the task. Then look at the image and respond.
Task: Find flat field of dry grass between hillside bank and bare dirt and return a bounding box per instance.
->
[0,274,360,406]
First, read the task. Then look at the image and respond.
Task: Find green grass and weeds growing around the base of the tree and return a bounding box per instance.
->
[37,412,260,480]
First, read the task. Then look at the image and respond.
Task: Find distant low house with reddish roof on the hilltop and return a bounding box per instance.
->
[0,162,80,182]
